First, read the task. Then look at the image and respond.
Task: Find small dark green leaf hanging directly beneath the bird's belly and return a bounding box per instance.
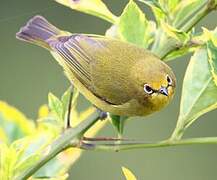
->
[109,114,128,137]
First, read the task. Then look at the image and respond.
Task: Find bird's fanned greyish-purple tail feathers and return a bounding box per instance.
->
[16,16,61,49]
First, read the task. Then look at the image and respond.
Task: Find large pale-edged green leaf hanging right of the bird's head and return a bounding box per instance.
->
[173,48,217,138]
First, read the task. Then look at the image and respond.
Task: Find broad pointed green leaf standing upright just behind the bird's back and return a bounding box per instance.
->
[118,0,154,48]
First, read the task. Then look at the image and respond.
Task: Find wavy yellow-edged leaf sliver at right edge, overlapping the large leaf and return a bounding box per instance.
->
[207,41,217,86]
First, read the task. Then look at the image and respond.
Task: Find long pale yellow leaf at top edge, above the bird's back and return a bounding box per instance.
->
[55,0,118,23]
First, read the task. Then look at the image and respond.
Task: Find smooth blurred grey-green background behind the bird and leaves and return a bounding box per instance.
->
[0,0,217,180]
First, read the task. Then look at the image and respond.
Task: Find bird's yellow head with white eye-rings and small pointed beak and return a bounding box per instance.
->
[131,57,176,114]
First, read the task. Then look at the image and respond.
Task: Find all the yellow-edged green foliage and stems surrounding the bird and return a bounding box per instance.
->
[0,0,217,180]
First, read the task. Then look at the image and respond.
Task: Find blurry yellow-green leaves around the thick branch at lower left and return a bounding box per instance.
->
[0,90,106,180]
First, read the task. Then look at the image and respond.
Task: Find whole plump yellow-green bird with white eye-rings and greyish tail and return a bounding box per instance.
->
[16,16,176,116]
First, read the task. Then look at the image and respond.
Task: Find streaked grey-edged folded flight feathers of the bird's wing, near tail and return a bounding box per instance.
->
[49,35,94,88]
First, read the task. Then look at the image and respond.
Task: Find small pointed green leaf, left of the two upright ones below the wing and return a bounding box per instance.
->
[48,93,63,121]
